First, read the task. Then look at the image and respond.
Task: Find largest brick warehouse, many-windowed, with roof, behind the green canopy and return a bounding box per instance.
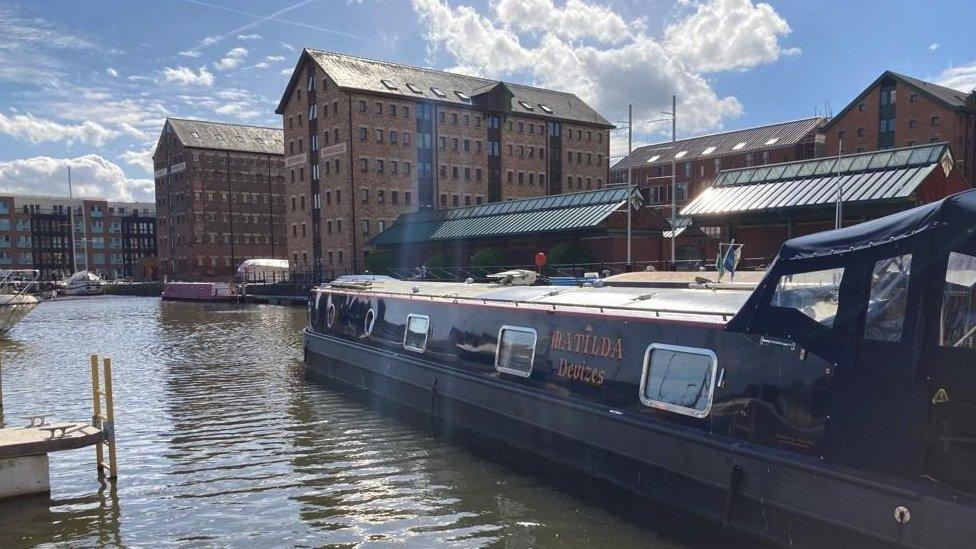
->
[276,49,613,275]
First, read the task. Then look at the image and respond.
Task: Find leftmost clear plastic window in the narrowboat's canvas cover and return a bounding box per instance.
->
[771,267,844,328]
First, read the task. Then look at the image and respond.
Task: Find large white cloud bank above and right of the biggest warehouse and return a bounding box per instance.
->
[408,0,748,134]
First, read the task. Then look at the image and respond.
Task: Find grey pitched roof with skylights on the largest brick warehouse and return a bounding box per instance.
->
[275,48,613,128]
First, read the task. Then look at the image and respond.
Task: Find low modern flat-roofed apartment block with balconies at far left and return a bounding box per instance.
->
[0,195,158,280]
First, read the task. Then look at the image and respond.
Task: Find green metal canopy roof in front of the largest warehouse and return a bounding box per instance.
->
[370,187,639,245]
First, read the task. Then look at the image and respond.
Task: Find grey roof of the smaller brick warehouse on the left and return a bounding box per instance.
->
[166,118,285,154]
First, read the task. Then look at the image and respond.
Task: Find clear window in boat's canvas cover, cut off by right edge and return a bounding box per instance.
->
[939,252,976,349]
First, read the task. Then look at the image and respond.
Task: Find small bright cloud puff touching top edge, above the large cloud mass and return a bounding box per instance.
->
[493,0,644,44]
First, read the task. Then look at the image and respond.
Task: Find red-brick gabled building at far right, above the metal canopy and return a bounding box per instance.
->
[824,71,976,185]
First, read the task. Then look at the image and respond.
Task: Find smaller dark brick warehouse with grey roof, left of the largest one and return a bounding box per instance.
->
[153,118,286,279]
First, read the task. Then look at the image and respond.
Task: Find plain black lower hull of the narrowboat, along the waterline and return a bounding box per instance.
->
[303,328,976,547]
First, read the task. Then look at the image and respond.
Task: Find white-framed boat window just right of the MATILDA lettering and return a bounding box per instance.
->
[640,343,718,417]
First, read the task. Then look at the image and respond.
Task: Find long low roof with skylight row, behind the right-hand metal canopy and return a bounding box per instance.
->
[610,116,827,171]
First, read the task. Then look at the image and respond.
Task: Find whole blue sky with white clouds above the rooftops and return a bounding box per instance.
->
[0,0,976,200]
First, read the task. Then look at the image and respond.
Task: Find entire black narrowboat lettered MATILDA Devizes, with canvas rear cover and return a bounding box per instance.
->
[304,191,976,547]
